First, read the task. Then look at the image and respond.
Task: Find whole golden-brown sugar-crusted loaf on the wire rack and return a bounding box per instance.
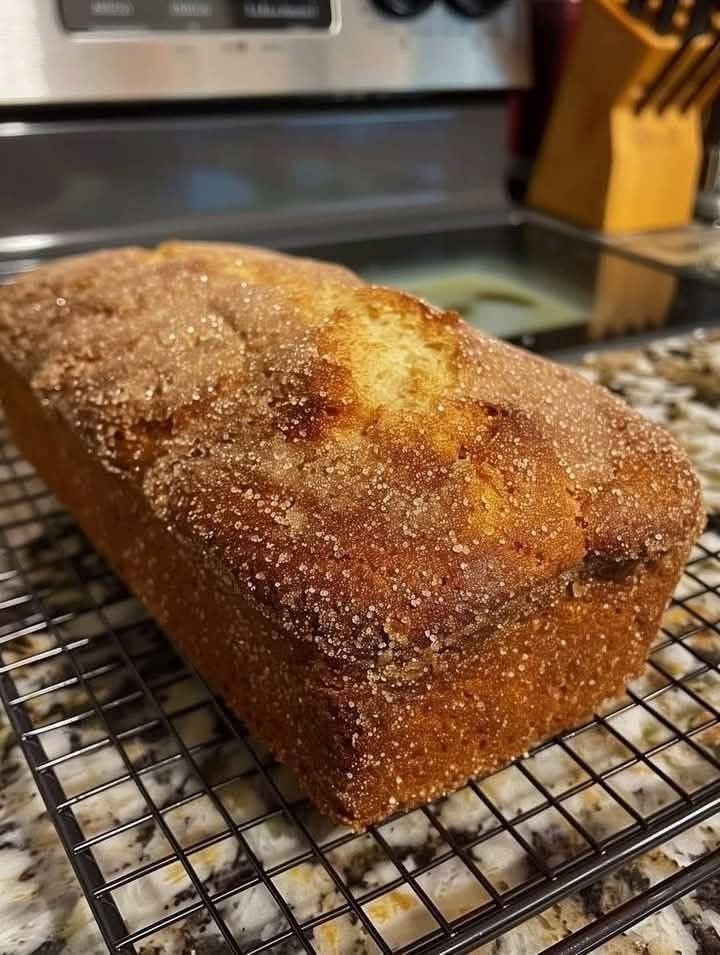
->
[0,242,703,826]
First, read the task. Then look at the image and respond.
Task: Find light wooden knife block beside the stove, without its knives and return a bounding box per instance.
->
[528,0,702,234]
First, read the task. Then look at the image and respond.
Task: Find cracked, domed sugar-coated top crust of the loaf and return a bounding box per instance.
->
[0,242,702,660]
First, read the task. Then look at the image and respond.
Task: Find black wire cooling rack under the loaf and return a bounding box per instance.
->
[0,419,720,955]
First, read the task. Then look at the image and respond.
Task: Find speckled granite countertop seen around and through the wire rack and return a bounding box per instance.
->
[0,332,720,955]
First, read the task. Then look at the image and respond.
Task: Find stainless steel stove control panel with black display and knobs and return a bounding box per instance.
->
[0,0,529,107]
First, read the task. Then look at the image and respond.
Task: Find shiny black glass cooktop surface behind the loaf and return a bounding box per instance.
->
[2,220,720,356]
